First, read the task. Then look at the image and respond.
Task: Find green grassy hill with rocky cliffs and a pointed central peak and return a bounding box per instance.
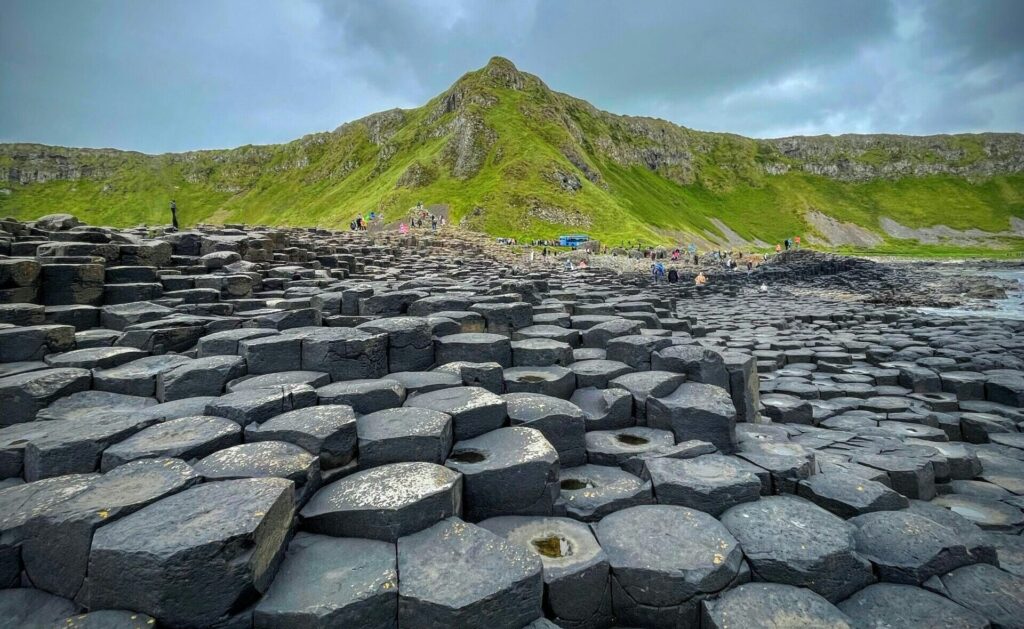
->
[0,57,1024,251]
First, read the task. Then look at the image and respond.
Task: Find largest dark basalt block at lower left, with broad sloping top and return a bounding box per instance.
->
[80,478,295,627]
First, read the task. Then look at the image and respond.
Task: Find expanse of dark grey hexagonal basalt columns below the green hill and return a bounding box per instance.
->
[0,219,1024,629]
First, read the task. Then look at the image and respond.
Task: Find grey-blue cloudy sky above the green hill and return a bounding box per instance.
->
[0,0,1024,153]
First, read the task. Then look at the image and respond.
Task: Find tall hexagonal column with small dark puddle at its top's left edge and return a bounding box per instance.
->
[445,426,558,521]
